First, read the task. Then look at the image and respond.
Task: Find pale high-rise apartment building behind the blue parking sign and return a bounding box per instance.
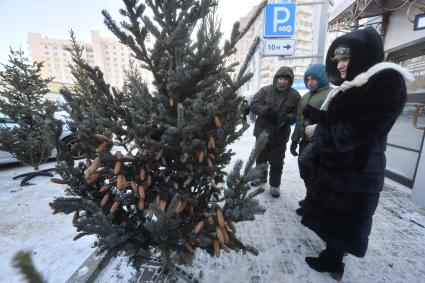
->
[230,6,314,96]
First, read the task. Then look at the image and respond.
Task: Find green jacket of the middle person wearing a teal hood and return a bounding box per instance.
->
[291,85,331,142]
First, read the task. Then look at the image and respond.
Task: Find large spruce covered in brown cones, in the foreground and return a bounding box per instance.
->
[50,0,267,271]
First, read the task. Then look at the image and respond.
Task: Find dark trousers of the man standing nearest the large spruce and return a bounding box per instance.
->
[256,144,286,187]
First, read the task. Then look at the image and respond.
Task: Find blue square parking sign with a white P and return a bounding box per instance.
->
[264,3,296,37]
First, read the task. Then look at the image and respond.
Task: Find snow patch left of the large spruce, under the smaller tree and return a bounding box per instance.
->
[0,162,95,283]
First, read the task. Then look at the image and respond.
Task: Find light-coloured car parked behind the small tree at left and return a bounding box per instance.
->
[0,111,85,165]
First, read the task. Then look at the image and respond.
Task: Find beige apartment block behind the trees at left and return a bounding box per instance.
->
[28,31,153,88]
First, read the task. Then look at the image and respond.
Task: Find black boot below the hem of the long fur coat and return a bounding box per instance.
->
[305,248,344,281]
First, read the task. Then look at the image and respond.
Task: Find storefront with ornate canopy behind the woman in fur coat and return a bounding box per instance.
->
[328,0,425,206]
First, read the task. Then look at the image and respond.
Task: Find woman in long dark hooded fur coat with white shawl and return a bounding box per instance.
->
[302,27,412,280]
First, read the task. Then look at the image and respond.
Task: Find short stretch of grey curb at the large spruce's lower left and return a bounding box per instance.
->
[66,249,112,283]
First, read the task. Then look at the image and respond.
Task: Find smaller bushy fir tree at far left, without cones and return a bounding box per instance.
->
[0,50,61,185]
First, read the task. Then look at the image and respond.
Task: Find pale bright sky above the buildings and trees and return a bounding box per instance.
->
[0,0,261,63]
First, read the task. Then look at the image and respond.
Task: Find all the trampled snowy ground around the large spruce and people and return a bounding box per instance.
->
[0,127,425,283]
